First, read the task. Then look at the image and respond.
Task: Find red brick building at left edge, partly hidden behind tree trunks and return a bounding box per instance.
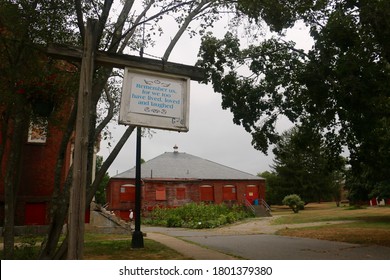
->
[0,111,72,226]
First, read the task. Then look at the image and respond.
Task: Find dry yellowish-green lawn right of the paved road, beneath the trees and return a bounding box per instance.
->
[273,203,390,247]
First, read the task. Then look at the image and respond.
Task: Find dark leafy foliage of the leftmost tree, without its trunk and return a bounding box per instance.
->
[0,0,73,111]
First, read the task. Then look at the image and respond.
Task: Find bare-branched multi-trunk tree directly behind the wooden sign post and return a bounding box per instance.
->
[41,0,251,258]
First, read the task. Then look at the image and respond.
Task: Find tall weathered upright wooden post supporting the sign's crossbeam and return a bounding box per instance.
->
[68,19,97,260]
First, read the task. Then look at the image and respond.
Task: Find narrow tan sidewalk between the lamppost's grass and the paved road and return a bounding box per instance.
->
[146,232,238,260]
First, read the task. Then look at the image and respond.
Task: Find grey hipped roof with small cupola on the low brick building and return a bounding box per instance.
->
[113,152,264,180]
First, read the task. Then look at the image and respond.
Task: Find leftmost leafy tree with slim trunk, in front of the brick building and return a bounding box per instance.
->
[0,0,77,259]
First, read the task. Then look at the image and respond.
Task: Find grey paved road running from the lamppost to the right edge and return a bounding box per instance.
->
[143,221,390,260]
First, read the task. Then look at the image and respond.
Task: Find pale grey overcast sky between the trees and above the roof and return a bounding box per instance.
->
[98,15,311,176]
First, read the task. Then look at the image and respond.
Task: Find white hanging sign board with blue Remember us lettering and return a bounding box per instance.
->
[119,68,190,132]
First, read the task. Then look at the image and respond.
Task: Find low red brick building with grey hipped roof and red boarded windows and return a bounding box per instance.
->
[106,147,265,220]
